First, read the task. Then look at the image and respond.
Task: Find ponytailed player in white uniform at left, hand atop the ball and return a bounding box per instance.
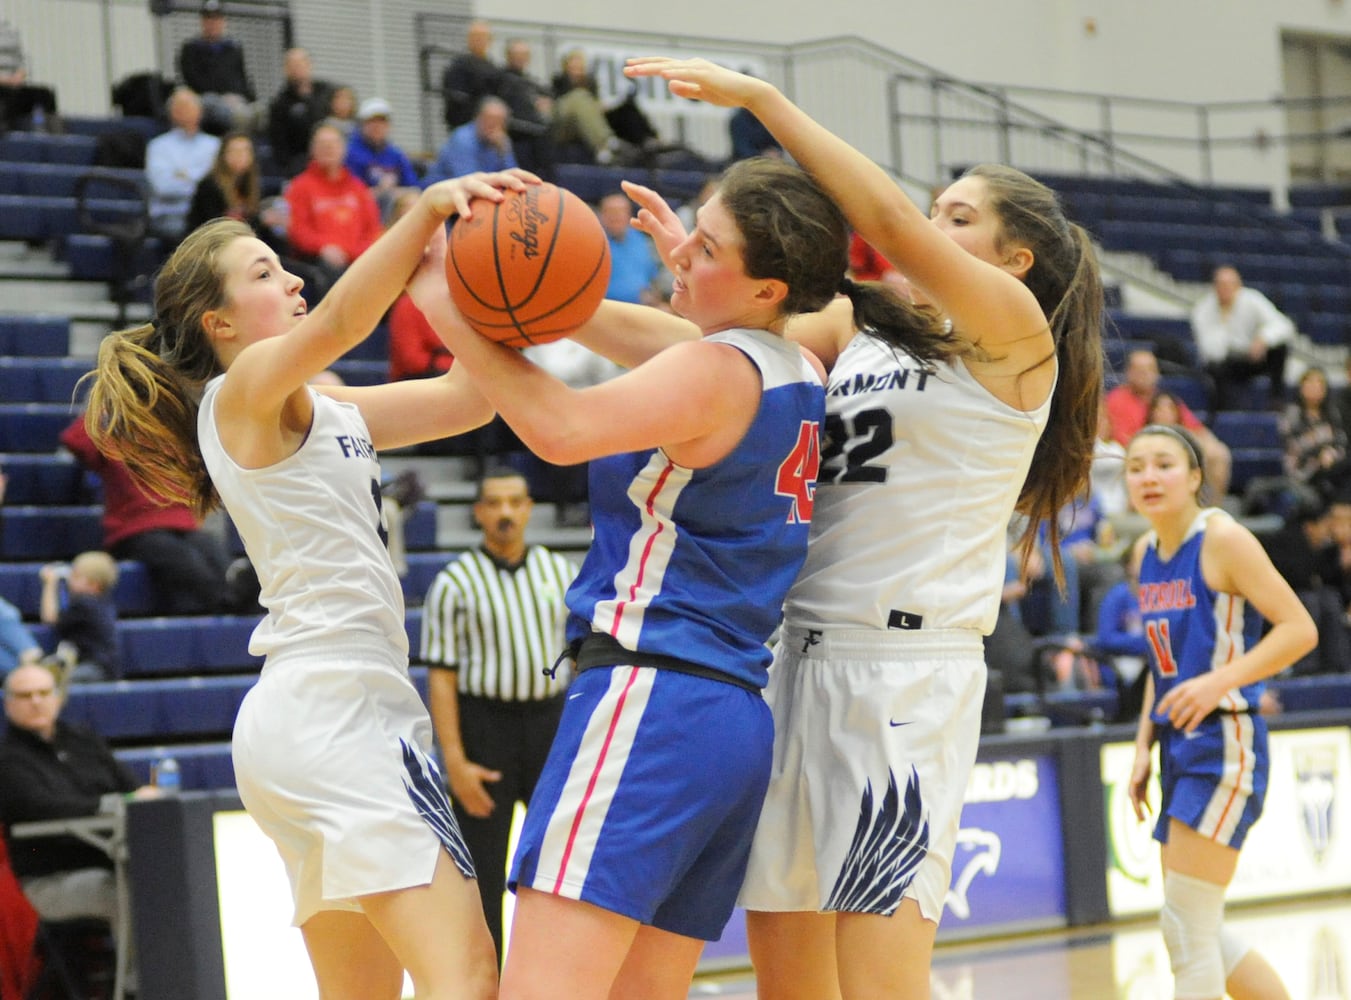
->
[86,173,532,1000]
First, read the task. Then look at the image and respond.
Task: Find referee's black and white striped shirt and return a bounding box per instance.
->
[422,545,577,701]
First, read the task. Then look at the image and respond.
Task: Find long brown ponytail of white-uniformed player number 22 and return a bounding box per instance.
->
[965,164,1102,580]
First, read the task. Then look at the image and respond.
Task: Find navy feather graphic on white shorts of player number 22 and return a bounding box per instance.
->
[825,768,928,916]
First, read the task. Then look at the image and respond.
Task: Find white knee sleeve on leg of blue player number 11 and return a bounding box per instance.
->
[1159,872,1242,1000]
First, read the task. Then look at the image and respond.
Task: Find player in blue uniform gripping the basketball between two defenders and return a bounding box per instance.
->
[426,161,948,1000]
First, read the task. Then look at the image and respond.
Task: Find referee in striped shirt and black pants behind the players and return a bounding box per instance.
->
[422,468,577,961]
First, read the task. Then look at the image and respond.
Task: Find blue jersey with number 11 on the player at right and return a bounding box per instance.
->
[1140,507,1263,726]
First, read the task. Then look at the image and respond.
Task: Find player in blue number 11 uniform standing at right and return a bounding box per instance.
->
[1125,424,1317,1000]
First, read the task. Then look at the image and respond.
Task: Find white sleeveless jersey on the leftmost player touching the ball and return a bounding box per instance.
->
[197,376,408,655]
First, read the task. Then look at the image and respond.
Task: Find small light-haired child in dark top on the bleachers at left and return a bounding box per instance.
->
[38,551,122,684]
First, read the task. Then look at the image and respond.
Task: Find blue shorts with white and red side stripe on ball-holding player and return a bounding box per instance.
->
[511,666,774,941]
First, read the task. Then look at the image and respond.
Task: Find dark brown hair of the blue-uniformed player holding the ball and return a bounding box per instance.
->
[717,157,967,361]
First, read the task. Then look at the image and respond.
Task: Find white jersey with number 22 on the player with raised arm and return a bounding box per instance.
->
[785,334,1051,634]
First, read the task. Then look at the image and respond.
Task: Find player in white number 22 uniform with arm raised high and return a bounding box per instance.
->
[605,58,1102,1000]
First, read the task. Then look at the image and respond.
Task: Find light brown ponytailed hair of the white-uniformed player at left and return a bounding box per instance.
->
[85,219,254,515]
